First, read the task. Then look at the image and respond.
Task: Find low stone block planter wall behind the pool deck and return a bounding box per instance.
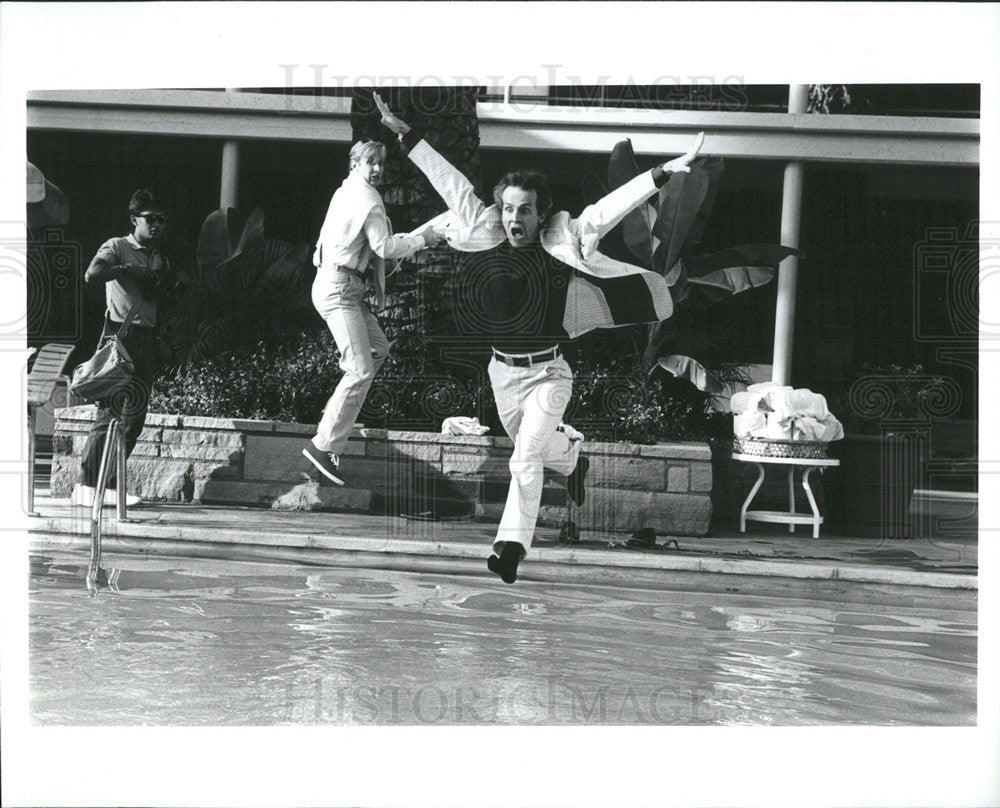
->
[52,406,712,536]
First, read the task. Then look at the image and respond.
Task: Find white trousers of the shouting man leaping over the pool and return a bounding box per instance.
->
[489,357,580,554]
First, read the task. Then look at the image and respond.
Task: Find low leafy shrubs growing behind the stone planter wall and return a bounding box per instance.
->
[151,331,732,443]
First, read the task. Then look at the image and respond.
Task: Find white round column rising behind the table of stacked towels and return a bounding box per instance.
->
[771,84,809,384]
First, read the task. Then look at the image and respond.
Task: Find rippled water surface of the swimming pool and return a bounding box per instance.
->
[30,554,976,725]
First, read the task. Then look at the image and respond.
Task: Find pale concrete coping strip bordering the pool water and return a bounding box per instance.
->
[30,514,978,607]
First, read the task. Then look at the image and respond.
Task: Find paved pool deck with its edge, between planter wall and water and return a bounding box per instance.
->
[28,492,978,603]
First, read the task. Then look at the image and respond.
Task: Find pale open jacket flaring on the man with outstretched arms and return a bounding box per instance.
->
[409,140,673,338]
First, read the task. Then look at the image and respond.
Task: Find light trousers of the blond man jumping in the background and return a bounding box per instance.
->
[312,269,389,454]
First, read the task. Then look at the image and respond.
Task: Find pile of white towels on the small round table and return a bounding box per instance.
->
[730,382,844,443]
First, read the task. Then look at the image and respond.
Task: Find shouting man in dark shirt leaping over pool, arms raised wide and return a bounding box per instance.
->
[375,94,703,583]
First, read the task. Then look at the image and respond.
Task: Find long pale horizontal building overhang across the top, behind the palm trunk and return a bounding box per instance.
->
[27,90,980,166]
